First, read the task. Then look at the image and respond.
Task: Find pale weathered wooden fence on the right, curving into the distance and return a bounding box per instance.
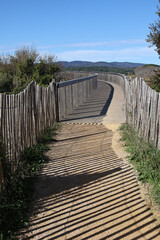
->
[62,72,160,149]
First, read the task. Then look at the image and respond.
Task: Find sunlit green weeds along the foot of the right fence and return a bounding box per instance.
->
[120,124,160,205]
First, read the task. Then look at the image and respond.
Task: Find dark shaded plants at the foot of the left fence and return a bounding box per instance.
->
[0,125,58,240]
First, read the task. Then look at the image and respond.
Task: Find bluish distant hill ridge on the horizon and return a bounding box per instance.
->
[60,61,145,68]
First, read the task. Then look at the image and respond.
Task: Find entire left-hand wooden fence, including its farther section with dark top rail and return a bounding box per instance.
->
[0,75,97,190]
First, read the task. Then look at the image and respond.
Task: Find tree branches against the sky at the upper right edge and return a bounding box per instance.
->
[146,1,160,57]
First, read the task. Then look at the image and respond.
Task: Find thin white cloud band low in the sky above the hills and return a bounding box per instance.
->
[0,39,159,64]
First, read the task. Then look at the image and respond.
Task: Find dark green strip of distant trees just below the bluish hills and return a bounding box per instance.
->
[65,66,134,75]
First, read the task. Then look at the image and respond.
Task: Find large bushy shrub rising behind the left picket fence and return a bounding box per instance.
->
[0,47,60,93]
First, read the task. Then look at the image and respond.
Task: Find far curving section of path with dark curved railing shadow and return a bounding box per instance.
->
[61,81,125,123]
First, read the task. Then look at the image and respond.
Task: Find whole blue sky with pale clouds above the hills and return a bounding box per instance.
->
[0,0,160,64]
